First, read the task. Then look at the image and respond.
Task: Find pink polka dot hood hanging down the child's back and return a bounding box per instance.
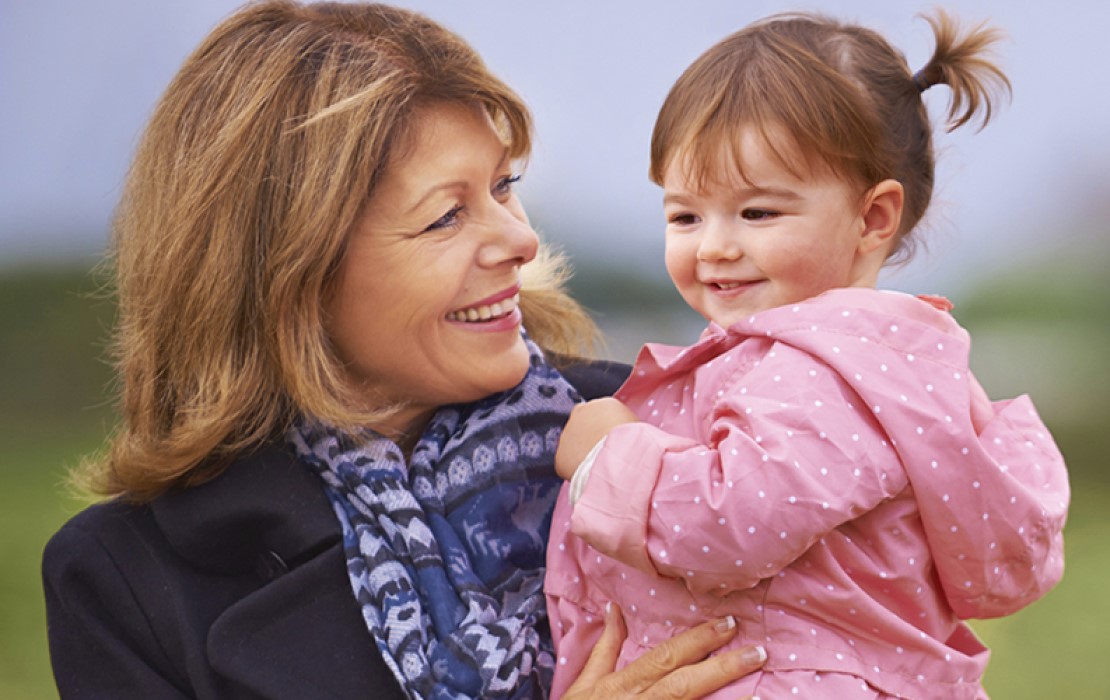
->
[755,290,1070,618]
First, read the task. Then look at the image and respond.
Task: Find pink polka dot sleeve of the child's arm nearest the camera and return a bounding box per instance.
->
[572,346,907,595]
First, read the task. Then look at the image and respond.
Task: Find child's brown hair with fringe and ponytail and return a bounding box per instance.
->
[650,9,1010,261]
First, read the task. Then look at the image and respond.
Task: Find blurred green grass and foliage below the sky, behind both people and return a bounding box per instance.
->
[0,256,1110,700]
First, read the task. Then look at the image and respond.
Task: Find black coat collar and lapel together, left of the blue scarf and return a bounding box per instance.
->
[153,444,404,699]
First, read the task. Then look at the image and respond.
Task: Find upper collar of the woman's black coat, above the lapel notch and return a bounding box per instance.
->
[152,442,342,574]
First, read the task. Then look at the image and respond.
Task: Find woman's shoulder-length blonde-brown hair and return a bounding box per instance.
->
[78,0,596,500]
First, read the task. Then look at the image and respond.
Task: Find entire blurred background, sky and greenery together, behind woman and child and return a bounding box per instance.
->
[0,0,1110,700]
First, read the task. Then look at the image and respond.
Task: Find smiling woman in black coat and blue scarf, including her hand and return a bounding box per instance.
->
[43,1,760,698]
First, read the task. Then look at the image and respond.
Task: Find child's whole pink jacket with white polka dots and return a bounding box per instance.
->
[546,288,1069,699]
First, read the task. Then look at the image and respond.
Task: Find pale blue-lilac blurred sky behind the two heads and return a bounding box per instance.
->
[0,0,1110,294]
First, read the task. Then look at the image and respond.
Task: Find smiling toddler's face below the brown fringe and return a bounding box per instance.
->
[663,130,870,327]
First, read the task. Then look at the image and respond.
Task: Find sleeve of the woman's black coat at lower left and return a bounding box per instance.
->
[42,512,189,700]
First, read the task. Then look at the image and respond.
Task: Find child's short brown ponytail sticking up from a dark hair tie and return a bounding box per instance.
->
[914,8,1010,131]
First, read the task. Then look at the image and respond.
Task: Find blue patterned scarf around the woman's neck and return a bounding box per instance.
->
[286,341,581,700]
